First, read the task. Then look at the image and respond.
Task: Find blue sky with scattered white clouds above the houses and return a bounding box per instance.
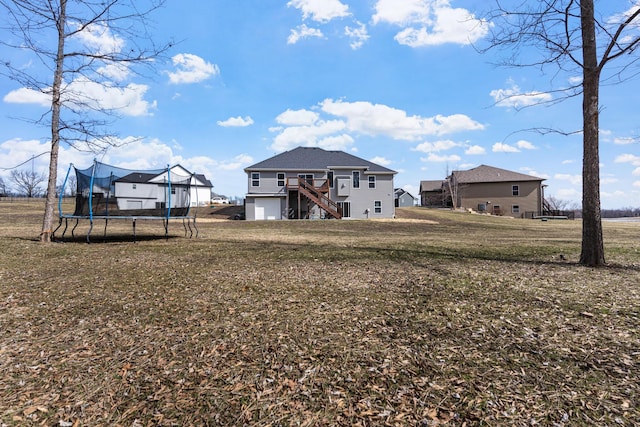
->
[0,0,640,209]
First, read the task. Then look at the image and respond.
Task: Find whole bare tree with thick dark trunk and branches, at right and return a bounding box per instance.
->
[487,0,640,266]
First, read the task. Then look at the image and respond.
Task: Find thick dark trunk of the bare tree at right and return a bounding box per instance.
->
[580,0,605,266]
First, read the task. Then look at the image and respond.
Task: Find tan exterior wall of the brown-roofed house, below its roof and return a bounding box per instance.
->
[458,181,542,218]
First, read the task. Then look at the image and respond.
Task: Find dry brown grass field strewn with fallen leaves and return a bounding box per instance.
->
[0,201,640,427]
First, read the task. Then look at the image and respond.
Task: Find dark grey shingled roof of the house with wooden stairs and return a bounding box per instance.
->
[245,147,397,174]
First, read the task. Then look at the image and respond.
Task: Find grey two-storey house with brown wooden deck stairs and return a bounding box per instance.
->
[245,147,396,220]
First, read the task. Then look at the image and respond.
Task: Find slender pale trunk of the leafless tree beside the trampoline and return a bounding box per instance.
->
[40,0,67,242]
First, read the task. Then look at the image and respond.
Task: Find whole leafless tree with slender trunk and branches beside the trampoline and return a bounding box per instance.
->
[0,0,171,242]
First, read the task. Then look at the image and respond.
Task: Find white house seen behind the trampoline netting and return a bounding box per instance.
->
[113,165,213,211]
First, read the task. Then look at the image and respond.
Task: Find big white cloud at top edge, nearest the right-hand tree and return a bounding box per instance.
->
[373,0,491,47]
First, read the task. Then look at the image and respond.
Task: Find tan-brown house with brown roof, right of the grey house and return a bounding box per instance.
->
[421,165,544,218]
